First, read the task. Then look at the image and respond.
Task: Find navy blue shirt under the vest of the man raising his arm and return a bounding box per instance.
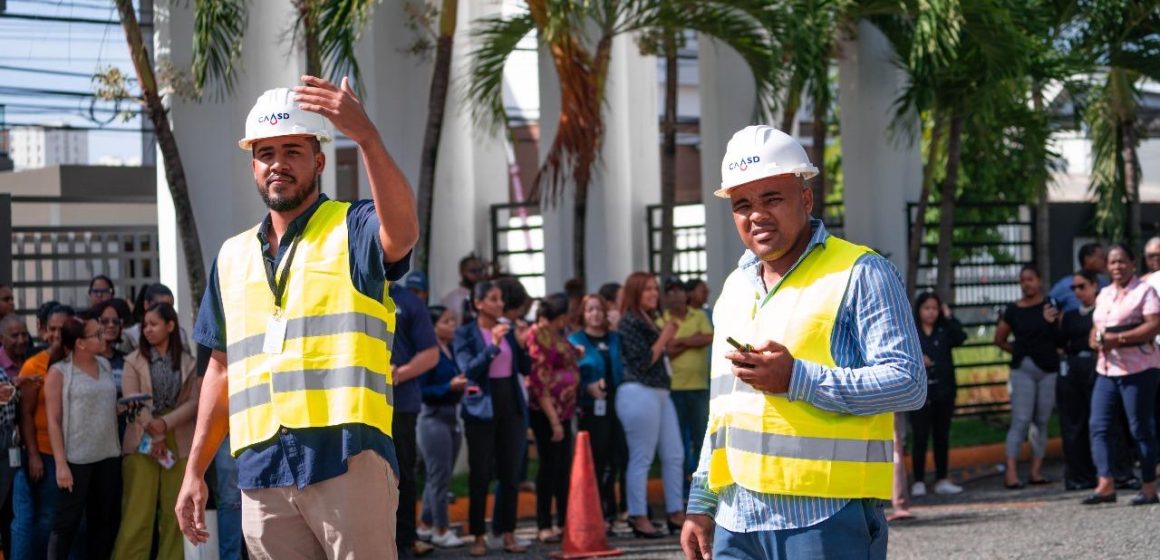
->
[194,195,411,490]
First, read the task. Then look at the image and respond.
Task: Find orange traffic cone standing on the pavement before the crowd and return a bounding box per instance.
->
[551,431,624,560]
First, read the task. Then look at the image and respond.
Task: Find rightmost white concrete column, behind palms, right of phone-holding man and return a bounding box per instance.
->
[838,21,922,270]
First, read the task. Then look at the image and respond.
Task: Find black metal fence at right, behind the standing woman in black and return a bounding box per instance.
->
[906,203,1034,416]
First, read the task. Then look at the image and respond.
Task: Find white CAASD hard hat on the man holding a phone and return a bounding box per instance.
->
[713,124,818,198]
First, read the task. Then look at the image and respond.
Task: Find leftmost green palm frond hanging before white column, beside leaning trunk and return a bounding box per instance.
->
[193,0,247,99]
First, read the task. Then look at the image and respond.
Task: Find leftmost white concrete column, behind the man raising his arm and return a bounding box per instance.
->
[155,1,308,325]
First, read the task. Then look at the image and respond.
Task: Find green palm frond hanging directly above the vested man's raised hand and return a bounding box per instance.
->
[310,0,382,95]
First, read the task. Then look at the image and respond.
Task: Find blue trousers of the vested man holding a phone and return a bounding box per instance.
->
[713,499,887,560]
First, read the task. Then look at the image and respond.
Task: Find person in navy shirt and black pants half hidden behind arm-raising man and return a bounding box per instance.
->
[389,283,438,558]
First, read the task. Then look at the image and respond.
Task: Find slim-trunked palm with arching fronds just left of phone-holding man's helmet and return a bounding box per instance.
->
[638,0,778,278]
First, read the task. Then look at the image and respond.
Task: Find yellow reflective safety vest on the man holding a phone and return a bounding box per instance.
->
[709,237,893,500]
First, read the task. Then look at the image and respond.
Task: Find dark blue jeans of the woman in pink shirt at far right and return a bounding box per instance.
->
[1090,369,1160,482]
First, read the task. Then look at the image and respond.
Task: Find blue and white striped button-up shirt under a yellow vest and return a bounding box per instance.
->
[688,220,927,532]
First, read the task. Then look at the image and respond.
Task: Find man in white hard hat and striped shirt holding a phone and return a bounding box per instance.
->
[681,126,927,559]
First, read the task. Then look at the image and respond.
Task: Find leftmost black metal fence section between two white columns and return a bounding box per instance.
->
[491,203,548,298]
